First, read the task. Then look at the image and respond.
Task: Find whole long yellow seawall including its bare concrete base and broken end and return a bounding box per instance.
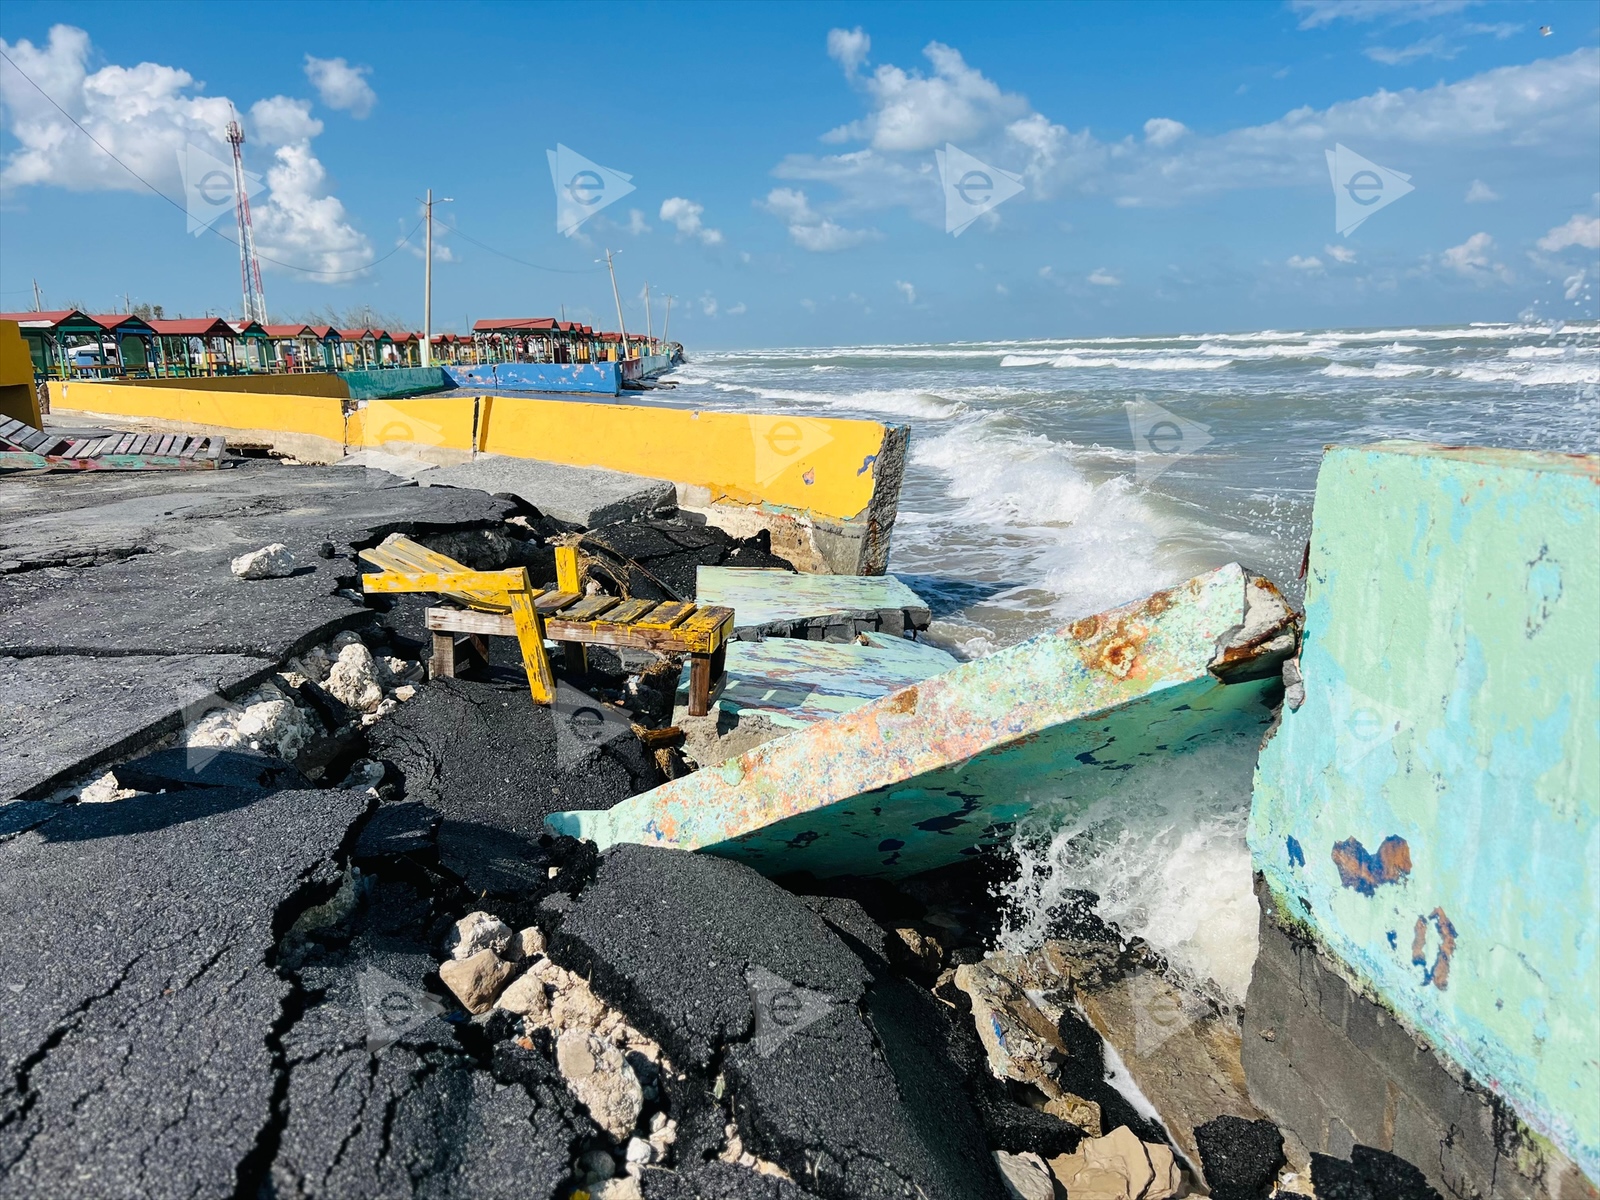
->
[50,385,907,574]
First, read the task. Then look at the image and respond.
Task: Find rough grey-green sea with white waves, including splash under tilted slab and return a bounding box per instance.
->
[651,322,1600,1003]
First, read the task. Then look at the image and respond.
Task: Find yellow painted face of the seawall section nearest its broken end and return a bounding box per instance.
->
[473,395,885,518]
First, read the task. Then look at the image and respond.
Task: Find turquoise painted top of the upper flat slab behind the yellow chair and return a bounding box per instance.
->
[694,566,928,640]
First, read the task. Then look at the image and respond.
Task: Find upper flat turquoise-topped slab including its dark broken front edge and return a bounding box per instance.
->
[694,566,931,642]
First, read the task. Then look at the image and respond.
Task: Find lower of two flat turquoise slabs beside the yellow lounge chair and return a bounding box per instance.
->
[678,633,958,730]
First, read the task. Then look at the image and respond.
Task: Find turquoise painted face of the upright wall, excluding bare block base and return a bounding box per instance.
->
[1250,442,1600,1179]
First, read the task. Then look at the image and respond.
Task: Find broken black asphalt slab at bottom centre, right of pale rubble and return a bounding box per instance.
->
[541,845,1002,1200]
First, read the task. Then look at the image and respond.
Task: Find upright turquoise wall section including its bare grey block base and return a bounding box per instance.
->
[1243,442,1600,1197]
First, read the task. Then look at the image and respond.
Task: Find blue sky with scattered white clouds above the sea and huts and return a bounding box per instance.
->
[0,0,1600,347]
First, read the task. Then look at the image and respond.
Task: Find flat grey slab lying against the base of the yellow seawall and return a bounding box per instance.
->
[416,454,678,530]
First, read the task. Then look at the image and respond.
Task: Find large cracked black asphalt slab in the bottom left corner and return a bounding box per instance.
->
[0,789,370,1197]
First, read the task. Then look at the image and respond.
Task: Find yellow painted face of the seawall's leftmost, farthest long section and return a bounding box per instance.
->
[50,379,344,446]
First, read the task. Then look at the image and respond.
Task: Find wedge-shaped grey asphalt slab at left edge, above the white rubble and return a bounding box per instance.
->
[0,654,272,805]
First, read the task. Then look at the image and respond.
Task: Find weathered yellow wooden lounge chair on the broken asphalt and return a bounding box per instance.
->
[360,534,733,717]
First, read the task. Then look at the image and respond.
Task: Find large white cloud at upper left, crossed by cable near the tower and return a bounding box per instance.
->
[0,26,373,280]
